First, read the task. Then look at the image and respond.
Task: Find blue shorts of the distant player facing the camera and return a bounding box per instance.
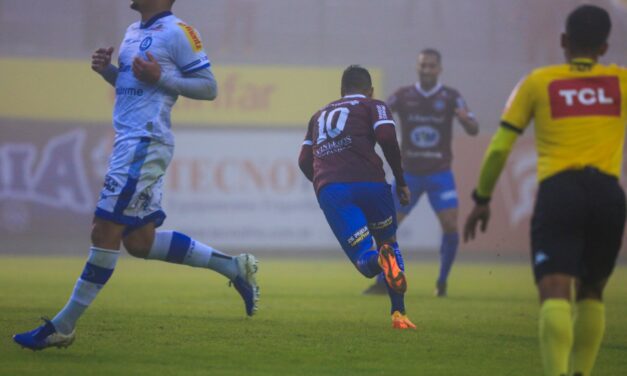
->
[394,170,459,215]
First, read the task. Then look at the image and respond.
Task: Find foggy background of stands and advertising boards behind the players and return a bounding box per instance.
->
[0,0,627,258]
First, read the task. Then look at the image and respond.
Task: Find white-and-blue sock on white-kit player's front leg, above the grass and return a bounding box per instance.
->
[51,247,120,335]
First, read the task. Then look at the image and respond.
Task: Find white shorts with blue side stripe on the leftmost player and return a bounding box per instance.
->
[95,137,174,233]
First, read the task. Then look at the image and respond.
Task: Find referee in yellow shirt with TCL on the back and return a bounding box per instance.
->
[464,5,627,376]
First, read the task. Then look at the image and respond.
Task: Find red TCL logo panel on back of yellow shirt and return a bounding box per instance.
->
[549,77,621,119]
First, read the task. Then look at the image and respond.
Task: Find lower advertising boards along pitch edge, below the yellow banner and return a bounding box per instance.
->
[0,119,624,255]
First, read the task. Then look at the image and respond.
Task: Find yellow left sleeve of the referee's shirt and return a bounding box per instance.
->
[501,76,534,133]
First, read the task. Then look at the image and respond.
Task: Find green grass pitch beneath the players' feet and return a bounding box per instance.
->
[0,257,627,376]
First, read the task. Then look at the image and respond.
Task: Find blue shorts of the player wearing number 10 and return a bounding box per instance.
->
[318,182,397,260]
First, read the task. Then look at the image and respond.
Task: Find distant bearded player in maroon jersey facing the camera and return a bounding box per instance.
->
[364,49,479,297]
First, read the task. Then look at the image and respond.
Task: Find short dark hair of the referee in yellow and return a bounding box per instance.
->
[566,5,612,52]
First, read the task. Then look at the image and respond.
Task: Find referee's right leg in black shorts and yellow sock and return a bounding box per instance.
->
[571,174,625,376]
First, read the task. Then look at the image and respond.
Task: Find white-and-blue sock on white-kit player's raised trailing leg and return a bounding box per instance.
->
[147,231,239,280]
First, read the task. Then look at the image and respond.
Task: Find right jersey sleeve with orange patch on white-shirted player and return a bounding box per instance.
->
[172,22,211,74]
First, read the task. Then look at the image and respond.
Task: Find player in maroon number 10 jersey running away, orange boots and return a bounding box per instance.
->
[299,65,415,329]
